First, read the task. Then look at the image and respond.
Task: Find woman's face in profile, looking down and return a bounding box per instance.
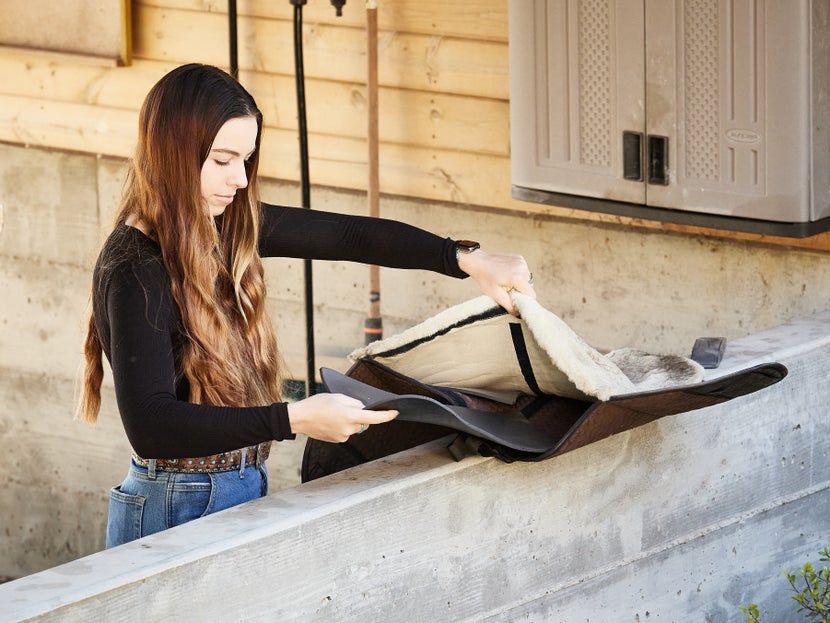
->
[202,117,257,216]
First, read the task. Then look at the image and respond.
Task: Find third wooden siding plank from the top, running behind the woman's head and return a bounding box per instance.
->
[0,56,510,156]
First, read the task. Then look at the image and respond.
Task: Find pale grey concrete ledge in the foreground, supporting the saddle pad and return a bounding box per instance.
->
[0,312,830,623]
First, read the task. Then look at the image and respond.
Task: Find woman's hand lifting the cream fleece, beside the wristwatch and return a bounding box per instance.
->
[458,249,536,316]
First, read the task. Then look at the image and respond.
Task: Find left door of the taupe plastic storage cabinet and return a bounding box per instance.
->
[510,0,648,204]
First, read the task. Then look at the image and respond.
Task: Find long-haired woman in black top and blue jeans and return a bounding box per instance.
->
[79,64,533,547]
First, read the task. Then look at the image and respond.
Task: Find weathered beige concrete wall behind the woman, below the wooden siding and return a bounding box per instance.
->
[0,143,830,577]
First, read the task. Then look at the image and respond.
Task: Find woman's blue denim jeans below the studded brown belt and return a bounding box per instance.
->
[107,459,268,548]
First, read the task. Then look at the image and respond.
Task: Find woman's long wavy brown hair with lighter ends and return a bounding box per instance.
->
[78,64,281,423]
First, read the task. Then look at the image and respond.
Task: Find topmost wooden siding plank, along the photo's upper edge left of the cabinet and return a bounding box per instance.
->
[136,0,507,43]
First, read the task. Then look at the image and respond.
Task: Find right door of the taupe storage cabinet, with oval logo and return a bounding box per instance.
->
[645,0,809,221]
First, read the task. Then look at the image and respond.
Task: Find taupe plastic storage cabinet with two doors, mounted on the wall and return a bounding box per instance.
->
[509,0,830,237]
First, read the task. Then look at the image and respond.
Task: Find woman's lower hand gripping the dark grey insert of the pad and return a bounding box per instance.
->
[288,394,398,443]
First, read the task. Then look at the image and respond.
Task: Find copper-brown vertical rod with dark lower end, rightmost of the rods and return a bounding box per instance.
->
[364,0,383,344]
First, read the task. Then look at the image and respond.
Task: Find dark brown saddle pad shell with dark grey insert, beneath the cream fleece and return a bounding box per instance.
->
[302,358,787,482]
